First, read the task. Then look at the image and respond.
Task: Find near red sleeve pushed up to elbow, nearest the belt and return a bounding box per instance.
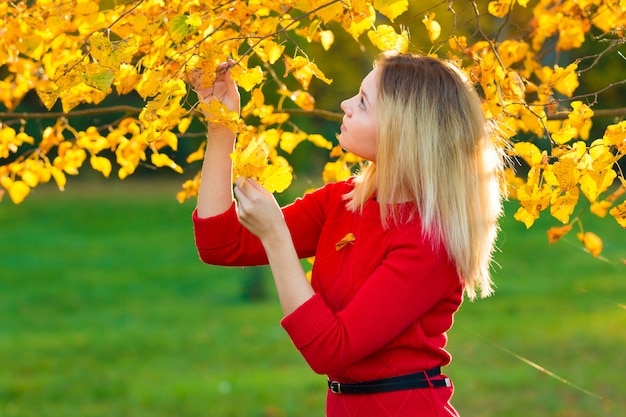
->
[282,229,462,374]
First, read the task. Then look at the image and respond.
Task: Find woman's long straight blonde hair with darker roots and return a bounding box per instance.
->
[345,54,503,299]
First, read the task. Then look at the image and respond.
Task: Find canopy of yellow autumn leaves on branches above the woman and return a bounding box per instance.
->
[0,0,626,256]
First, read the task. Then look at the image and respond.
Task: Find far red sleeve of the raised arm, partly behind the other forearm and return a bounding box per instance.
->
[192,183,348,266]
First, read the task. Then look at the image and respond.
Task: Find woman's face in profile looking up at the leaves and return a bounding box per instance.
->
[339,68,380,161]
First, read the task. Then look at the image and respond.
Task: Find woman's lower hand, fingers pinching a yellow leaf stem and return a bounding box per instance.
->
[235,178,291,240]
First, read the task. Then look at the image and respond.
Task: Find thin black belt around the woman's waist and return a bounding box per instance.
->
[328,367,452,394]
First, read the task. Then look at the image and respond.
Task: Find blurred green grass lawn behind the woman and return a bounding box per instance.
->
[0,180,626,417]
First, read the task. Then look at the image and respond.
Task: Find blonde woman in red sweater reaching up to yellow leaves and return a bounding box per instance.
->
[193,54,502,417]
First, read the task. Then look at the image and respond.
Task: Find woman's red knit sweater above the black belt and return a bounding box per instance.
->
[193,181,463,415]
